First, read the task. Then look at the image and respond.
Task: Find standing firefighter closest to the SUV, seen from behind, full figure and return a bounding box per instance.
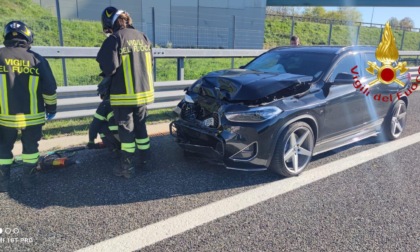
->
[96,7,154,178]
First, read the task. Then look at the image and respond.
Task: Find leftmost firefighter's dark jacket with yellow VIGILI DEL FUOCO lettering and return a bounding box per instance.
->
[0,42,57,129]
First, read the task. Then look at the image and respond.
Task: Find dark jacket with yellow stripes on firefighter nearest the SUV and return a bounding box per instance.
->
[96,27,154,107]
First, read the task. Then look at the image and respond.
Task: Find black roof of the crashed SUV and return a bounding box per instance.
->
[270,45,376,54]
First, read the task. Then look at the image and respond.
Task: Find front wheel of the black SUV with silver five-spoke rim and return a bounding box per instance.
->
[270,122,315,177]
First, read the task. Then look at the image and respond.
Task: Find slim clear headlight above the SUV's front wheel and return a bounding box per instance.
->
[225,107,283,123]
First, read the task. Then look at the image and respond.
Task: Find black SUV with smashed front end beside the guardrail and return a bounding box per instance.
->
[170,46,411,176]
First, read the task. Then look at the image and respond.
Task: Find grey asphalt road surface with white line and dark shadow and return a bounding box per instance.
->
[0,92,420,251]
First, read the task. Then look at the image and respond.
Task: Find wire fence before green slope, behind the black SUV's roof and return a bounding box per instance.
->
[264,14,420,51]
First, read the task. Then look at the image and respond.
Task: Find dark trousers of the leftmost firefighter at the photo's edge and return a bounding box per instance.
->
[0,125,42,164]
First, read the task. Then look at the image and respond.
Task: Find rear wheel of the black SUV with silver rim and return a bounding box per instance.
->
[382,100,407,140]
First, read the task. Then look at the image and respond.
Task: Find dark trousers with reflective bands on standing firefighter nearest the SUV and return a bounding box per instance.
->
[112,106,150,153]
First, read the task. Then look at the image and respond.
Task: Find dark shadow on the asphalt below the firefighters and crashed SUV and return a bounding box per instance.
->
[5,136,281,209]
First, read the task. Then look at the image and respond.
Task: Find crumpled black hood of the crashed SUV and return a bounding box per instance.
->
[189,69,312,101]
